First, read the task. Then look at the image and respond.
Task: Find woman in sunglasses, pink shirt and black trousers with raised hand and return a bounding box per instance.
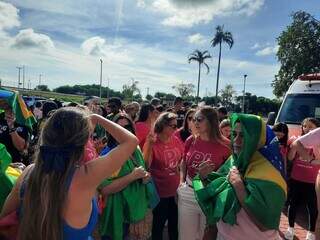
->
[143,112,183,240]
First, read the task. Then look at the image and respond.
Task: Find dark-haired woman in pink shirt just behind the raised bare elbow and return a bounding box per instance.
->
[135,103,160,149]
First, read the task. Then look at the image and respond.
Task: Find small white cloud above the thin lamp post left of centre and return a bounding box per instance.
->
[81,36,132,62]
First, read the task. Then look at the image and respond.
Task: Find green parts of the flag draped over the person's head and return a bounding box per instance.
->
[193,114,286,229]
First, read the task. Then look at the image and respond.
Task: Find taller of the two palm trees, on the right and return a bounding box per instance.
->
[211,25,234,99]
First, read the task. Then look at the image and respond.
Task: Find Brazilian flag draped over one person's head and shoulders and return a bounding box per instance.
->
[193,114,287,229]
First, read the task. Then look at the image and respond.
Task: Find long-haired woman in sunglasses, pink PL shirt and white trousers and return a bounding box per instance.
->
[178,106,231,240]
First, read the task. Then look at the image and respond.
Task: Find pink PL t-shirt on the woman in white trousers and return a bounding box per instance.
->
[184,136,231,179]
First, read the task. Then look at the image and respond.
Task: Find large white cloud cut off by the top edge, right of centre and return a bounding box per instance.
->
[152,0,264,27]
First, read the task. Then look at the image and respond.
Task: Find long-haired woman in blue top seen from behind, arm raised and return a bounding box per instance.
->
[0,108,137,240]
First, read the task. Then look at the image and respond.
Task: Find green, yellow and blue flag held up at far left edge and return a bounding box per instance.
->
[0,88,36,130]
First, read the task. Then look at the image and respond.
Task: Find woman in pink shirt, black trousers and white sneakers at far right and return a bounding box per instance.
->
[285,118,320,240]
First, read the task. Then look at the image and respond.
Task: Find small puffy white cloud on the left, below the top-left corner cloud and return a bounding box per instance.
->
[11,28,54,50]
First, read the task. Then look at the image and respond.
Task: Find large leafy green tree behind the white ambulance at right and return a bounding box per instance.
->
[272,11,320,97]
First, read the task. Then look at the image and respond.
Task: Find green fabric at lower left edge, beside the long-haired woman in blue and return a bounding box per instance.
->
[0,143,16,211]
